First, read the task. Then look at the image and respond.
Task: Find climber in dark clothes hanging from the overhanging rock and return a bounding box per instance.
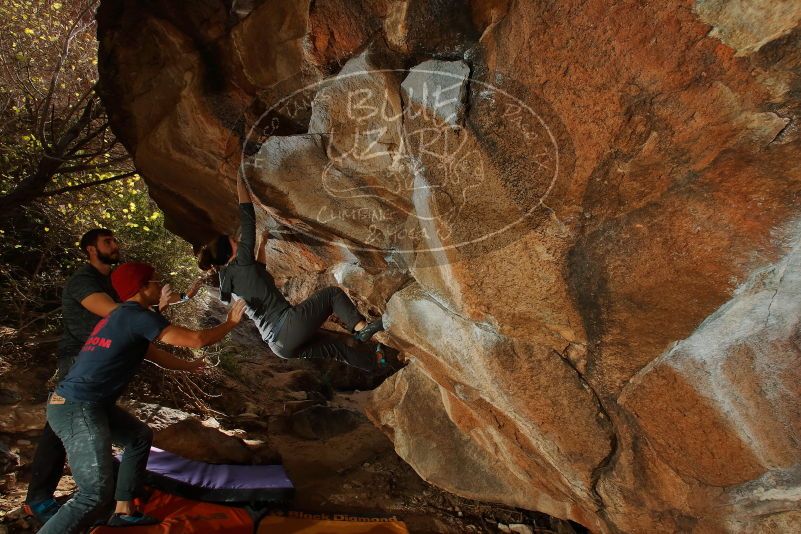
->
[198,175,387,371]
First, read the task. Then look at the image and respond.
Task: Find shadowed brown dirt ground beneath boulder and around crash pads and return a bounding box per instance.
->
[0,316,584,534]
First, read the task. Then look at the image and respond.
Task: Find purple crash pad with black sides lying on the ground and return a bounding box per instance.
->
[134,447,295,502]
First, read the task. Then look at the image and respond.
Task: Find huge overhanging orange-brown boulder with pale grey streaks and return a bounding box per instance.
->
[98,0,801,533]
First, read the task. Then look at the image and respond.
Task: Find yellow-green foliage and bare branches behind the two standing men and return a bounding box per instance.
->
[0,0,198,334]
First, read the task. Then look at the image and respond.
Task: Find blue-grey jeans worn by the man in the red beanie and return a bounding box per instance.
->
[39,398,153,534]
